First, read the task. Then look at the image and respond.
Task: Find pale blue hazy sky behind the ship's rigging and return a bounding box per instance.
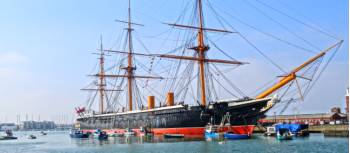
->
[0,0,349,122]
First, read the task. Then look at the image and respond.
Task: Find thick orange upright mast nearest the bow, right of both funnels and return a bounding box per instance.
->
[196,0,207,106]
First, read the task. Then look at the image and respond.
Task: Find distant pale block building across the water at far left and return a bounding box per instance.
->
[20,121,56,130]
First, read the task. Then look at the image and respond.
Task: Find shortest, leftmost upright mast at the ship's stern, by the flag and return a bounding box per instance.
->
[99,36,105,114]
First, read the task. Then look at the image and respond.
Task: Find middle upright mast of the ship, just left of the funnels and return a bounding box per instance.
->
[126,0,134,111]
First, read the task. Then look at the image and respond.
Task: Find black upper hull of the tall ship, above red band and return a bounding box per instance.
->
[77,98,276,134]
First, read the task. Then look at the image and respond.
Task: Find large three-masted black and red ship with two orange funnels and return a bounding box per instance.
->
[76,0,342,135]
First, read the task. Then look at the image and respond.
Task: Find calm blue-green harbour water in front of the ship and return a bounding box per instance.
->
[0,131,349,153]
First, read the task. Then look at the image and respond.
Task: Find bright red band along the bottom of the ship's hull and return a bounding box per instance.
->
[83,125,254,135]
